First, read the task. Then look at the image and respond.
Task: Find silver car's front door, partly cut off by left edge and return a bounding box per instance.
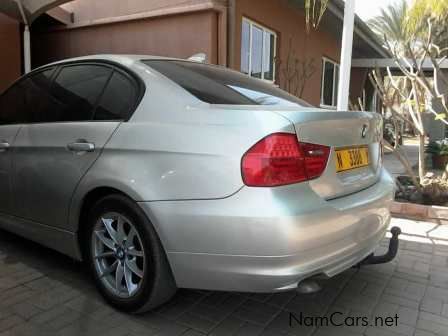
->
[0,82,24,215]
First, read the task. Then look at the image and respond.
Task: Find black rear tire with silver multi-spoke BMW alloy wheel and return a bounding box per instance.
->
[85,195,177,313]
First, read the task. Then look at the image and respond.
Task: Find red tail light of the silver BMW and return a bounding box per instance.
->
[241,133,330,187]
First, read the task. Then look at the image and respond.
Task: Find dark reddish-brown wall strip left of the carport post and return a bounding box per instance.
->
[0,14,21,93]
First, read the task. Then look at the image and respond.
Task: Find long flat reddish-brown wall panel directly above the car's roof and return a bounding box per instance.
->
[32,10,218,66]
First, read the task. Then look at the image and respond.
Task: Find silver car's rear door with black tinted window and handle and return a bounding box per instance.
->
[14,64,140,228]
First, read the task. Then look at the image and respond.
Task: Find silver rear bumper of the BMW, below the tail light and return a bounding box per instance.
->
[140,170,394,292]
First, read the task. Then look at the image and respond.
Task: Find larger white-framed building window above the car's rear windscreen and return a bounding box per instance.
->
[241,19,277,81]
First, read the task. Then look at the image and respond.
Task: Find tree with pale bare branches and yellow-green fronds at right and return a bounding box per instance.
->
[371,0,448,201]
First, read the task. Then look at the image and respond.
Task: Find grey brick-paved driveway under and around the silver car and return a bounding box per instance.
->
[0,219,448,336]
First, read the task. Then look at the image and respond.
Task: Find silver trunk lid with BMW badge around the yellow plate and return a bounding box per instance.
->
[276,109,382,199]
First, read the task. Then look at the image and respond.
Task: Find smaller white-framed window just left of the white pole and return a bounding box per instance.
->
[320,58,339,107]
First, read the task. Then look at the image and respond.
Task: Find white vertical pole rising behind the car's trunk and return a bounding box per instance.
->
[338,0,356,111]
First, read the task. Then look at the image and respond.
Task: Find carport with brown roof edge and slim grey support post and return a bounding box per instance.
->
[0,0,73,72]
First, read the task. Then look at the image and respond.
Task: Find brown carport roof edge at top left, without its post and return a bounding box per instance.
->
[0,0,73,25]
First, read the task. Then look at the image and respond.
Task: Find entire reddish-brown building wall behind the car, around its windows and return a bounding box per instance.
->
[33,0,372,106]
